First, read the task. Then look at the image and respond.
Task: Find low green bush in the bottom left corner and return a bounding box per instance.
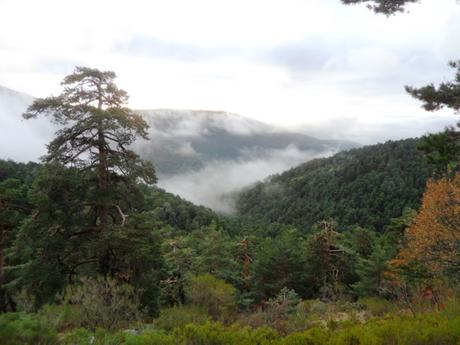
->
[0,313,57,345]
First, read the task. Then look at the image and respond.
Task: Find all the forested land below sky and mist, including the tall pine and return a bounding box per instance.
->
[0,64,460,345]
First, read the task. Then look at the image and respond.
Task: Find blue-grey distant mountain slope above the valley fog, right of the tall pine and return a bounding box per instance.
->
[135,109,357,175]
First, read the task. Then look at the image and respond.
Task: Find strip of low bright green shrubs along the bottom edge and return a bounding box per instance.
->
[0,311,460,345]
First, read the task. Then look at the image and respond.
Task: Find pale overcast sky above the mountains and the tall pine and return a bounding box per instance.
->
[0,0,460,143]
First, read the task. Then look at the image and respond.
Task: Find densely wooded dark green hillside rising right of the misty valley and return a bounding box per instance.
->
[237,139,431,231]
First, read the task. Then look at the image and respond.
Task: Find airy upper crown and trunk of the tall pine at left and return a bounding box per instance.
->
[23,67,156,231]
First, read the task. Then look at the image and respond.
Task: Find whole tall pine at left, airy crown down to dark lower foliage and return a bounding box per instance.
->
[10,67,162,314]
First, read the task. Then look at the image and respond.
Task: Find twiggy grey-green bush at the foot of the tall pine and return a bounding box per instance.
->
[63,278,140,330]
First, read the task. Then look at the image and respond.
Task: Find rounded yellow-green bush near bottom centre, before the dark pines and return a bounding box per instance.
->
[185,274,237,321]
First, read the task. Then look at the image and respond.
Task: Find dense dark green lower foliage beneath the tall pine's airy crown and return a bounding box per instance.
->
[6,165,162,314]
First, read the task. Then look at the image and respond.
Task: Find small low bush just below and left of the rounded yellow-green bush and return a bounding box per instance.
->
[154,306,209,331]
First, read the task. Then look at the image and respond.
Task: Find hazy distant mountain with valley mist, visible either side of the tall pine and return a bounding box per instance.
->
[0,87,357,212]
